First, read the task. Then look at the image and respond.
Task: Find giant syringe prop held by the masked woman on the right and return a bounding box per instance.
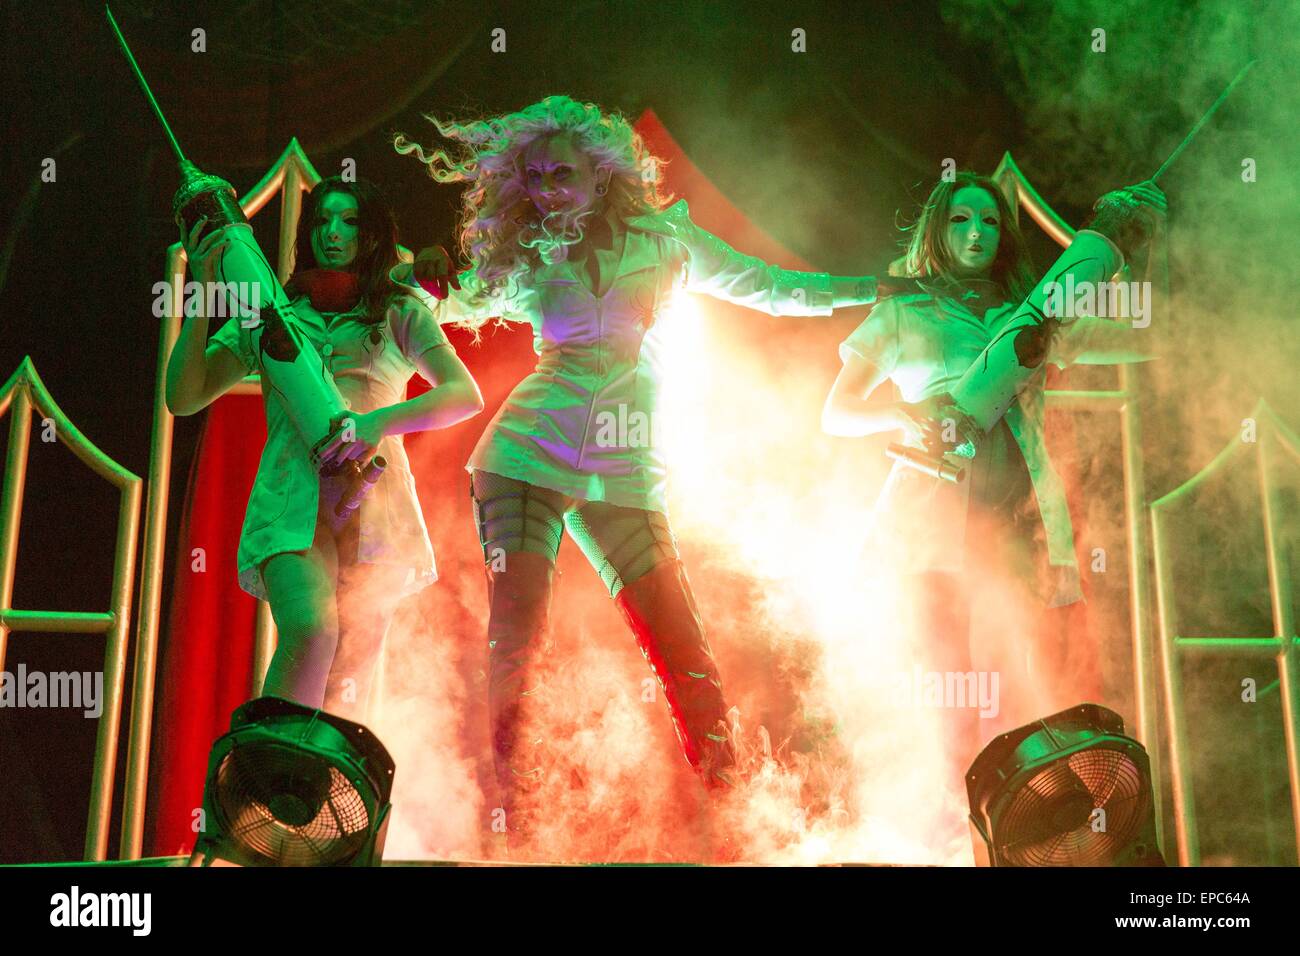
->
[885,60,1256,481]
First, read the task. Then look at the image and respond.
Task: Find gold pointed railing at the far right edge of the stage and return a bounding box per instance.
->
[1151,399,1300,866]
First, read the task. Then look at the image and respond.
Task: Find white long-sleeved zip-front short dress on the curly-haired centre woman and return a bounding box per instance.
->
[421,200,832,512]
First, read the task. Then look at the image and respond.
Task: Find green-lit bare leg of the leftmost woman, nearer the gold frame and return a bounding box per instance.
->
[263,523,338,708]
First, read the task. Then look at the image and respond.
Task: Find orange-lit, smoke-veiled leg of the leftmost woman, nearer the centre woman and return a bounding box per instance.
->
[325,563,410,723]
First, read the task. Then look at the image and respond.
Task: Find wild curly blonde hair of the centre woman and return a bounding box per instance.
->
[393,95,668,323]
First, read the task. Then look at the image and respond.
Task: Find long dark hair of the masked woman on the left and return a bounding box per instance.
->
[285,176,402,324]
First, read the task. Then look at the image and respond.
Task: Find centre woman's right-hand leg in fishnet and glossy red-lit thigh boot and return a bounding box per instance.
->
[566,502,736,787]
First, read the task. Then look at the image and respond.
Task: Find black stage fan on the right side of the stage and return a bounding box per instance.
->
[966,704,1164,866]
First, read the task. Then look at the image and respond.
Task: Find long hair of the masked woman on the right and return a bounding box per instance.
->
[905,170,1036,302]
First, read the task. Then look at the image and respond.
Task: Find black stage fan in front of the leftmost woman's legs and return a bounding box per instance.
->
[191,697,394,866]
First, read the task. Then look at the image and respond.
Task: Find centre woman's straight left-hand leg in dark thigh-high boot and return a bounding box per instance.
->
[471,471,569,834]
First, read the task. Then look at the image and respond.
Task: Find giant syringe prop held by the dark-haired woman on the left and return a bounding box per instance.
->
[104,5,387,531]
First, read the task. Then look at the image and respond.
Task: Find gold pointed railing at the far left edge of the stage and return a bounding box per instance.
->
[0,355,140,860]
